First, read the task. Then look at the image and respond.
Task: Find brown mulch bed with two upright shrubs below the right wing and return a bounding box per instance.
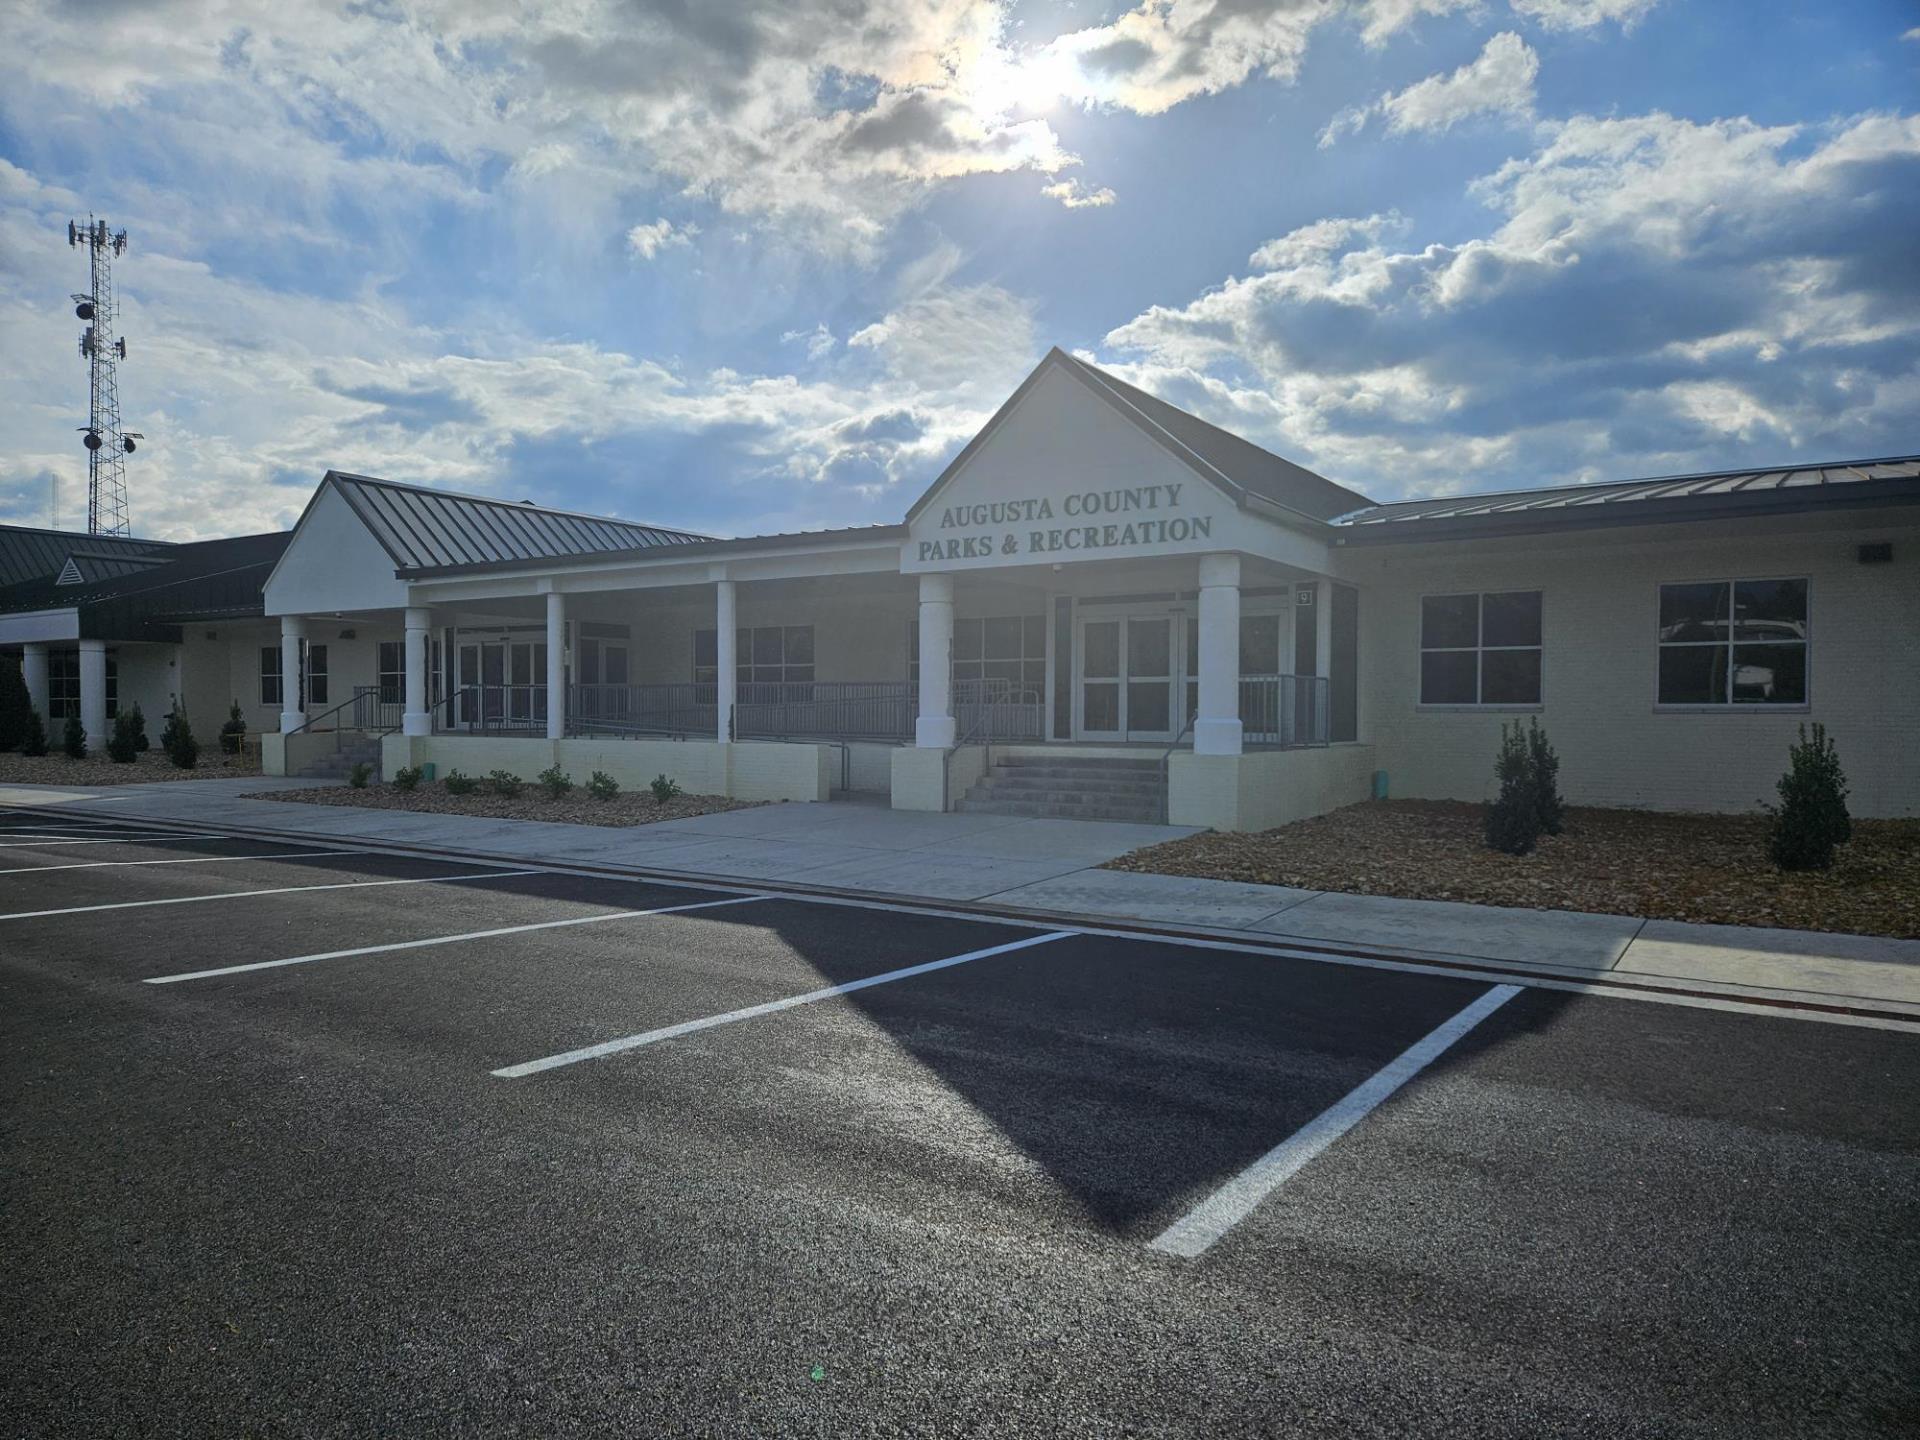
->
[1108,801,1920,939]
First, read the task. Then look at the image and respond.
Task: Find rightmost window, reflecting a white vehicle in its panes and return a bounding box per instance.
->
[1659,580,1807,705]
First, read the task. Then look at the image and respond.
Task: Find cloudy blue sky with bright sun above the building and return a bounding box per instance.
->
[0,0,1920,540]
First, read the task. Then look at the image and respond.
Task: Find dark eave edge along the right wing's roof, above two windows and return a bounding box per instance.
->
[1332,480,1920,549]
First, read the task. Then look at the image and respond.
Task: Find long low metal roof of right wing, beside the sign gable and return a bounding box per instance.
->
[1334,455,1920,545]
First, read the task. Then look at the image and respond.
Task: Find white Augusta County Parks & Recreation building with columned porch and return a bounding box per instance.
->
[0,349,1920,829]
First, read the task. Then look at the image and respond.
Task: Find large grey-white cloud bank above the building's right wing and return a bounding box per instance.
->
[1106,113,1920,495]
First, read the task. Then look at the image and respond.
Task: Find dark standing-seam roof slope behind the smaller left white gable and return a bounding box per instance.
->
[326,470,707,570]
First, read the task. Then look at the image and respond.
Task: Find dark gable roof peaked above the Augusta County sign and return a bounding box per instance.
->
[906,346,1373,522]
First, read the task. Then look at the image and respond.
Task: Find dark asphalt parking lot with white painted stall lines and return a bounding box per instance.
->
[0,810,1920,1436]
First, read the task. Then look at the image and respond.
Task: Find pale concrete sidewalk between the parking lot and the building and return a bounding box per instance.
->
[0,778,1920,1023]
